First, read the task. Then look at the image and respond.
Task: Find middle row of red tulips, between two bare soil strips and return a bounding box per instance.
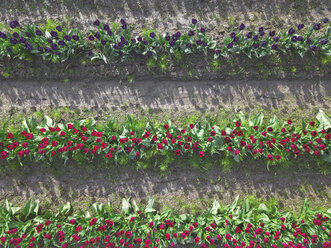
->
[0,110,331,166]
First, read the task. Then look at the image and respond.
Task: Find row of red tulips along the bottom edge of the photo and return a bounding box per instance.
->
[0,197,331,248]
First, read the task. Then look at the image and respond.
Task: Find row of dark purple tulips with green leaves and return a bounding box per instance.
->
[0,18,331,63]
